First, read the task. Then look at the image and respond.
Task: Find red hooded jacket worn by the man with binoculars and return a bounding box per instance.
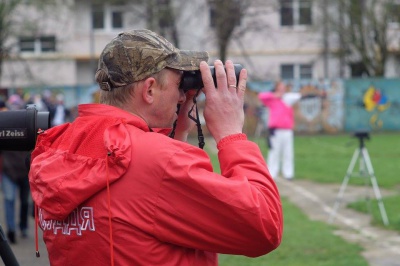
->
[29,104,283,266]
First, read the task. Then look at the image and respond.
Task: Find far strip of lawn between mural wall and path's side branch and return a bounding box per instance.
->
[255,133,400,188]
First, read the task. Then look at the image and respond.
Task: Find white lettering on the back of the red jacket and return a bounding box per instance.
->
[39,207,96,236]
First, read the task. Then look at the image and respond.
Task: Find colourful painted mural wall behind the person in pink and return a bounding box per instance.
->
[249,78,400,135]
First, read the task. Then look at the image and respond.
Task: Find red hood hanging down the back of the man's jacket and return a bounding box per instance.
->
[29,104,170,220]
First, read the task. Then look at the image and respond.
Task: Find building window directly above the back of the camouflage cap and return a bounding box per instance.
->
[92,5,124,31]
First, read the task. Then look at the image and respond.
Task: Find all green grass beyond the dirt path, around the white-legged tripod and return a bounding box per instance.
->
[254,132,400,231]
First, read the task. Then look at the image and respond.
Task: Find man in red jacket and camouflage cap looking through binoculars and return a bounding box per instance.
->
[29,30,283,266]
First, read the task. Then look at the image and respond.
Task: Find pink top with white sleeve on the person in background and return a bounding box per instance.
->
[258,92,301,129]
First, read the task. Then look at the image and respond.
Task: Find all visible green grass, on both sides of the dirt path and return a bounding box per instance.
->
[206,133,400,266]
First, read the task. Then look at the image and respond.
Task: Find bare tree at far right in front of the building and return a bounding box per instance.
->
[327,0,400,77]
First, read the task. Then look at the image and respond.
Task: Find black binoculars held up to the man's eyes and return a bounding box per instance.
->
[179,64,243,92]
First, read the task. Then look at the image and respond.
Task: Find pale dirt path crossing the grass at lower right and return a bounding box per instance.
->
[276,179,400,266]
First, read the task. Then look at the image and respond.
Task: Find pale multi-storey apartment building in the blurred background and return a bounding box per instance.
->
[0,0,400,96]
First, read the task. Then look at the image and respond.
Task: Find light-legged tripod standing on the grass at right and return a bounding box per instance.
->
[329,131,389,225]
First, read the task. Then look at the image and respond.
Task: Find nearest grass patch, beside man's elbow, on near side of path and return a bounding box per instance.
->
[219,198,368,266]
